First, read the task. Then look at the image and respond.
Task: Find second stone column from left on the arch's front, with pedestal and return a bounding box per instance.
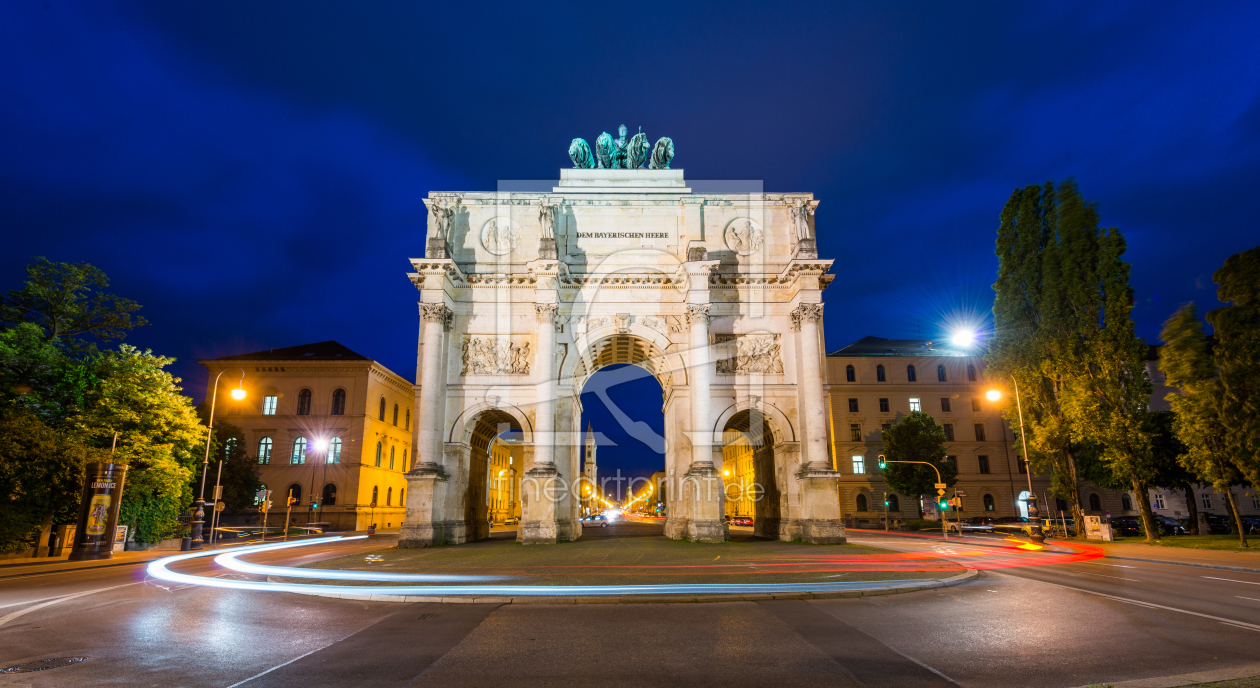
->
[517,304,559,544]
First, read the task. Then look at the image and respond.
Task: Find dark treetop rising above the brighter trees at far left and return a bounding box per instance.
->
[0,256,147,348]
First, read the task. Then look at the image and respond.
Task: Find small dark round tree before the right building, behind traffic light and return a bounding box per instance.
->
[883,411,958,515]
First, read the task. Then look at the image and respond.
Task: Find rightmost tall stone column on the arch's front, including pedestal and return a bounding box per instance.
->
[781,304,845,544]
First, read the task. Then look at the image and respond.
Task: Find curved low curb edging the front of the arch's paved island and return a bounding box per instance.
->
[267,568,980,605]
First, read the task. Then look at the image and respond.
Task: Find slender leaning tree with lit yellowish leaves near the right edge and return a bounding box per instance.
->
[1159,304,1247,547]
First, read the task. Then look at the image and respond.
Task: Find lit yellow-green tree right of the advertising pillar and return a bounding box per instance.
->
[74,344,205,542]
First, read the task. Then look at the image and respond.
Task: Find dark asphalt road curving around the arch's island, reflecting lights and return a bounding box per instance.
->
[0,524,1260,688]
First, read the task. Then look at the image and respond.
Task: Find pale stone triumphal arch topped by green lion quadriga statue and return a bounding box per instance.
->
[399,130,844,547]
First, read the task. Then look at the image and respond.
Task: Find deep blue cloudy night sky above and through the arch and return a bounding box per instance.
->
[0,0,1260,471]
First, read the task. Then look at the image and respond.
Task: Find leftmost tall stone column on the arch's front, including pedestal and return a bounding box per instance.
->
[398,304,454,547]
